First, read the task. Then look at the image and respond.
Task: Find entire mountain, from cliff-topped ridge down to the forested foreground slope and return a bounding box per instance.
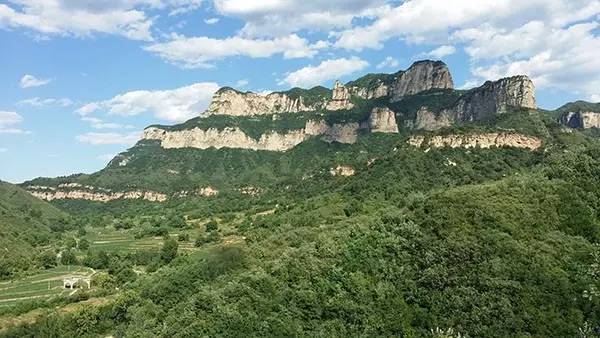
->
[6,61,600,338]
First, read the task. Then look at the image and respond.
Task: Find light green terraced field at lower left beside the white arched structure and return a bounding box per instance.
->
[0,266,94,306]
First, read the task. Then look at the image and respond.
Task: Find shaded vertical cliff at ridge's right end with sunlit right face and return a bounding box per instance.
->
[452,75,536,121]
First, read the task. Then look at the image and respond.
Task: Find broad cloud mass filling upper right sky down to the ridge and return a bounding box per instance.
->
[332,0,600,99]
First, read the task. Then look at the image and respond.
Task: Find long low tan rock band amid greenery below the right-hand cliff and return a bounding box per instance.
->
[408,133,542,150]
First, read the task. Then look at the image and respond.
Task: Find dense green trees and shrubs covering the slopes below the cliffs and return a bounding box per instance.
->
[2,96,600,337]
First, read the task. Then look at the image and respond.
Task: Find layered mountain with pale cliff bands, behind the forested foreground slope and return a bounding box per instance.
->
[22,60,545,205]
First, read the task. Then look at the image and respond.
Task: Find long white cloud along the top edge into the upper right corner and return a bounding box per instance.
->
[336,0,600,50]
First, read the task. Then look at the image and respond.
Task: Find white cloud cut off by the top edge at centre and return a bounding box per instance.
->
[214,0,385,36]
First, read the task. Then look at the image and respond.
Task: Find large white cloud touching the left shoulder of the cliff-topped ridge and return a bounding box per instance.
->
[76,82,219,122]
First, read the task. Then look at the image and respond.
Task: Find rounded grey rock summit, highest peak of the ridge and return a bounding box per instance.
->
[390,60,454,102]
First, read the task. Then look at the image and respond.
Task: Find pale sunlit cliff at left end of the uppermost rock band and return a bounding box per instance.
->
[204,87,317,116]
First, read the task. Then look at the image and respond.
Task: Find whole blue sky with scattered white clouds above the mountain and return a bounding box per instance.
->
[0,0,600,183]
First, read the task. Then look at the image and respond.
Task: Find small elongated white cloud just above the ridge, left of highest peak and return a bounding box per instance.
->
[280,57,369,88]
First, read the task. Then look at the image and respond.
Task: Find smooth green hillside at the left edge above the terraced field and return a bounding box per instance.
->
[0,181,68,278]
